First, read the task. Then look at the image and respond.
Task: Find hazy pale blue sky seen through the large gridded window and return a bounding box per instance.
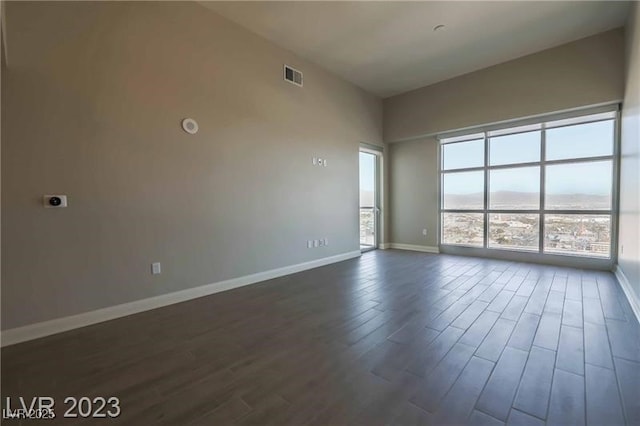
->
[443,120,614,195]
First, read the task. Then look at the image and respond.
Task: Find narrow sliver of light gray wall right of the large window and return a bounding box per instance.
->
[618,3,640,306]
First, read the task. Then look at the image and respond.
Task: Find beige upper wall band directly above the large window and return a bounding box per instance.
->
[384,29,624,142]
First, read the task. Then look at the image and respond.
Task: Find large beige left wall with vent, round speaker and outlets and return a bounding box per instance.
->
[2,2,382,329]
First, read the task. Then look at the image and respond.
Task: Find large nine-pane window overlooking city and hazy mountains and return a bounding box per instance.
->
[440,111,617,259]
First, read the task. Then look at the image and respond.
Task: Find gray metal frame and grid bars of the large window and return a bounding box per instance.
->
[437,104,620,269]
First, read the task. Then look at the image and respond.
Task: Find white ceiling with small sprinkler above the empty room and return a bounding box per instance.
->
[200,1,630,97]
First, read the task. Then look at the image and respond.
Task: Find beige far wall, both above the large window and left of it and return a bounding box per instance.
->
[384,29,624,250]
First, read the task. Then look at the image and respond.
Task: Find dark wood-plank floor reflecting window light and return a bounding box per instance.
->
[2,250,640,425]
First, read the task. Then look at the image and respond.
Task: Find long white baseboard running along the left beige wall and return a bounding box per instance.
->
[0,250,361,347]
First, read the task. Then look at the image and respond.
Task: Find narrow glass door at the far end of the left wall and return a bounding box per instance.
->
[360,151,380,251]
